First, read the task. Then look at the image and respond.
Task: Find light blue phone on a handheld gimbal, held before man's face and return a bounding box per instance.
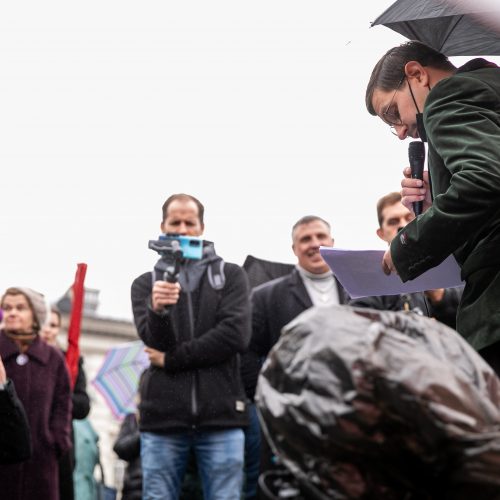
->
[148,233,203,283]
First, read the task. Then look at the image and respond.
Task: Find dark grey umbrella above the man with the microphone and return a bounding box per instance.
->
[372,0,500,56]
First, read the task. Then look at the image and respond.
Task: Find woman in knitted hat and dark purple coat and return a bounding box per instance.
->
[0,288,71,500]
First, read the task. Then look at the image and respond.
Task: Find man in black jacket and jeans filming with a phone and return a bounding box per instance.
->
[132,194,250,500]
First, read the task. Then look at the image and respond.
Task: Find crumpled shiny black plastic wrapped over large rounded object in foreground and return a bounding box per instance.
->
[256,306,500,500]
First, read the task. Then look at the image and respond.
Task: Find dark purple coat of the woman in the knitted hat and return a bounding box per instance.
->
[0,332,71,500]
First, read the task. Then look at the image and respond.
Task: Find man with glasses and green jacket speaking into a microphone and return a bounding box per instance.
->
[366,41,500,373]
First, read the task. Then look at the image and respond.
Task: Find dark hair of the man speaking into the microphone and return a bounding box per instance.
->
[365,40,456,115]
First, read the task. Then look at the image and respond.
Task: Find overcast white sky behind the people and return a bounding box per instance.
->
[0,0,496,319]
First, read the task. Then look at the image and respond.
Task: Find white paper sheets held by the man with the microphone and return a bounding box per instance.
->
[320,247,464,299]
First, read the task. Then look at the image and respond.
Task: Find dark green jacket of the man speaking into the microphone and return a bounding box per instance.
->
[391,59,500,350]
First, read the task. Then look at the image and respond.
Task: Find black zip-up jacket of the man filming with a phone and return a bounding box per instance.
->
[132,248,250,432]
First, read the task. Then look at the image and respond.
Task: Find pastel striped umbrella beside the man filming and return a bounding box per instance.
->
[92,340,149,419]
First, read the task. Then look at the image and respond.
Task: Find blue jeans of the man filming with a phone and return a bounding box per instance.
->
[141,429,244,500]
